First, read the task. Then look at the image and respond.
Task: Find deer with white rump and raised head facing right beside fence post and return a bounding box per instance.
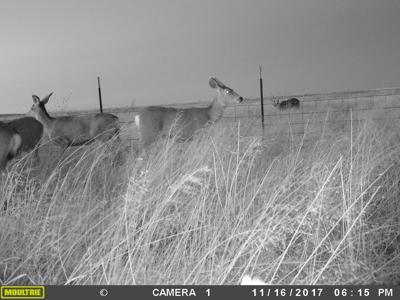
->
[135,77,243,147]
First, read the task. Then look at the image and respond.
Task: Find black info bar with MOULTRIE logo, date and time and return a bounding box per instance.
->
[0,285,400,300]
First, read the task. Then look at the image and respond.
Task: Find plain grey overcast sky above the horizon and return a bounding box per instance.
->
[0,0,400,114]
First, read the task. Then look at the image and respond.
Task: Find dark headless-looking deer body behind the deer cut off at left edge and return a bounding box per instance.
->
[7,117,43,160]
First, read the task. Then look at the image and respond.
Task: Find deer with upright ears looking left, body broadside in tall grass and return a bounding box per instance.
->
[28,93,119,151]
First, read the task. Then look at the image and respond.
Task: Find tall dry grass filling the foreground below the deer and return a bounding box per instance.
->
[0,114,400,284]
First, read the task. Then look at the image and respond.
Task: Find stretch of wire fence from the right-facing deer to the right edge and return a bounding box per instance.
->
[224,88,400,142]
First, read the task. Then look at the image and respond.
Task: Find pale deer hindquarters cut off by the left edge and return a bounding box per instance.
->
[0,122,22,171]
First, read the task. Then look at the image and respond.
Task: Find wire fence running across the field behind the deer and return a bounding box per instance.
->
[0,88,400,154]
